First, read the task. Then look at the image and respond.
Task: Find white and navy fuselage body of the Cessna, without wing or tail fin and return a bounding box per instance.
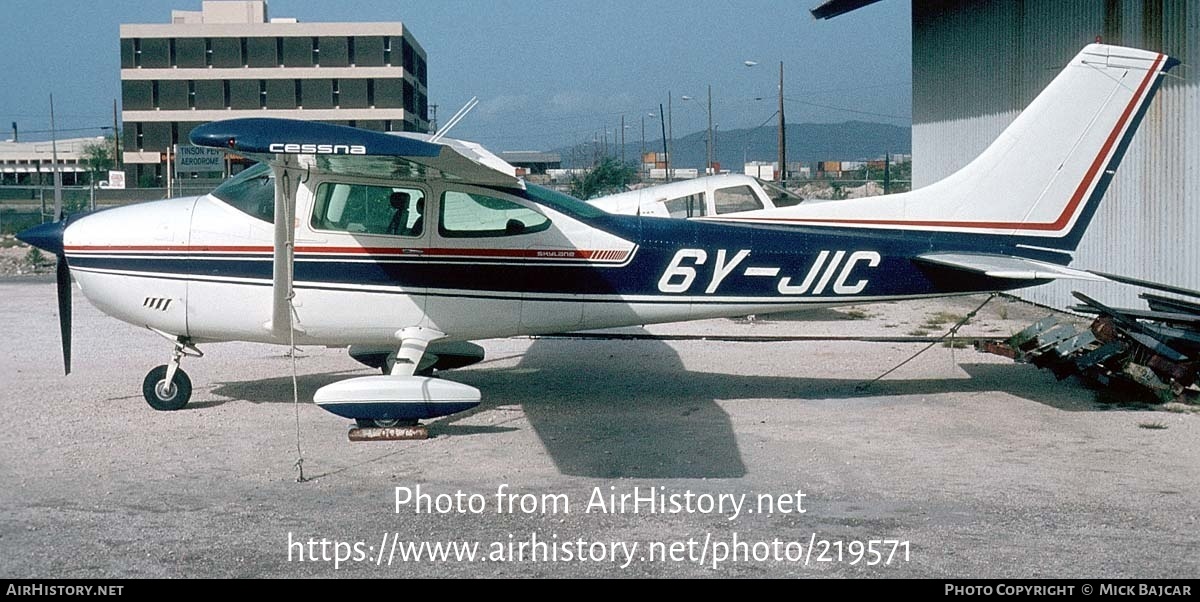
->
[64,180,1027,345]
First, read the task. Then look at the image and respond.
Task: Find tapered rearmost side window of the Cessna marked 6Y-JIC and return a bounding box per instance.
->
[438,191,550,239]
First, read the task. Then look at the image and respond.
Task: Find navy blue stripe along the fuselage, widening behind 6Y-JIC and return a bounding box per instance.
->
[68,216,1041,302]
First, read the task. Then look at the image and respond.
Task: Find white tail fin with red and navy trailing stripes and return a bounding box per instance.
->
[748,44,1178,251]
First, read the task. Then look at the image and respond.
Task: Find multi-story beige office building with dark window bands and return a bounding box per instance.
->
[121,0,428,186]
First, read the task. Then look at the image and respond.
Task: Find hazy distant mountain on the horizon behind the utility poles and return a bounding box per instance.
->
[553,121,912,170]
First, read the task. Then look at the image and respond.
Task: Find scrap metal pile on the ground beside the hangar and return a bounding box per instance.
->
[976,275,1200,403]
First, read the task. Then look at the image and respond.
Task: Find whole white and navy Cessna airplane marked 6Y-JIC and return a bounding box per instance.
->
[20,44,1177,426]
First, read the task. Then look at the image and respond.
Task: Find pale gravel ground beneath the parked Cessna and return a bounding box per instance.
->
[0,276,1200,578]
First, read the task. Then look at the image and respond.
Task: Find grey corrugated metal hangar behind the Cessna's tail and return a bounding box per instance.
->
[814,0,1200,307]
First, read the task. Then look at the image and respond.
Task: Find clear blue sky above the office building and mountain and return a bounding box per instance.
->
[0,0,912,151]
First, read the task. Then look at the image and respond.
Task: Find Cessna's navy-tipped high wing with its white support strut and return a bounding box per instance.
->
[191,118,524,338]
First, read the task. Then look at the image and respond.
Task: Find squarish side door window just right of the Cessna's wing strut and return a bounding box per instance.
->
[312,182,425,236]
